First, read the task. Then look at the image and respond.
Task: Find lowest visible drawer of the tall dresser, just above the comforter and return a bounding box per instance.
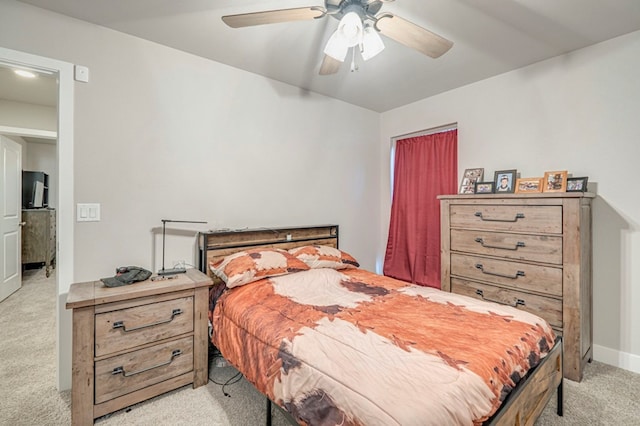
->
[451,278,562,328]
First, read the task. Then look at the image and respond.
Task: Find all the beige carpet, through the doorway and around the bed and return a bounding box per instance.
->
[0,270,640,426]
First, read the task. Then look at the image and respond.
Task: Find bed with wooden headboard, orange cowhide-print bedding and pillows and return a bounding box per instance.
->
[199,225,562,425]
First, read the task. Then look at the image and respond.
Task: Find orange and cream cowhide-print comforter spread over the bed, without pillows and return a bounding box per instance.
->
[209,269,555,425]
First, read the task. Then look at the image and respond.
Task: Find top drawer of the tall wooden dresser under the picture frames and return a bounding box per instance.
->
[449,204,562,234]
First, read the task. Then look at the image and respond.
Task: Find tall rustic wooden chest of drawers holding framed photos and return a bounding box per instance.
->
[438,192,594,381]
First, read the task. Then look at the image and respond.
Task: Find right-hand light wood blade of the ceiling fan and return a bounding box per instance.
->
[375,13,453,58]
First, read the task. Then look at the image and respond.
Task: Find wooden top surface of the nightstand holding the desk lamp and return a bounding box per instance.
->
[65,269,213,309]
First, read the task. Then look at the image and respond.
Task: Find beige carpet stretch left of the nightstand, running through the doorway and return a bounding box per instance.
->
[0,268,71,425]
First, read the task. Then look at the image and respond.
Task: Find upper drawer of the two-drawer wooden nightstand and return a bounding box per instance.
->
[95,297,193,357]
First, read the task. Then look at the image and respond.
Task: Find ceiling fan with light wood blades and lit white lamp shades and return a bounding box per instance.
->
[222,0,453,75]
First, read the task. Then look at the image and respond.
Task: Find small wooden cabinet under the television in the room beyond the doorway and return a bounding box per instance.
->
[22,209,56,277]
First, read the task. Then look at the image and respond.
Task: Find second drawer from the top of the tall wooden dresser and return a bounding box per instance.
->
[451,229,562,265]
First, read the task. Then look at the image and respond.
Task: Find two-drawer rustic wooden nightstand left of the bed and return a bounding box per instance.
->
[66,269,212,425]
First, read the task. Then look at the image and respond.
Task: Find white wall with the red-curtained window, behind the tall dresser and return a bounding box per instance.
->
[379,32,640,372]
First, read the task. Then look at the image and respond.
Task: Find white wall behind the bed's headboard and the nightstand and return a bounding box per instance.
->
[0,0,380,392]
